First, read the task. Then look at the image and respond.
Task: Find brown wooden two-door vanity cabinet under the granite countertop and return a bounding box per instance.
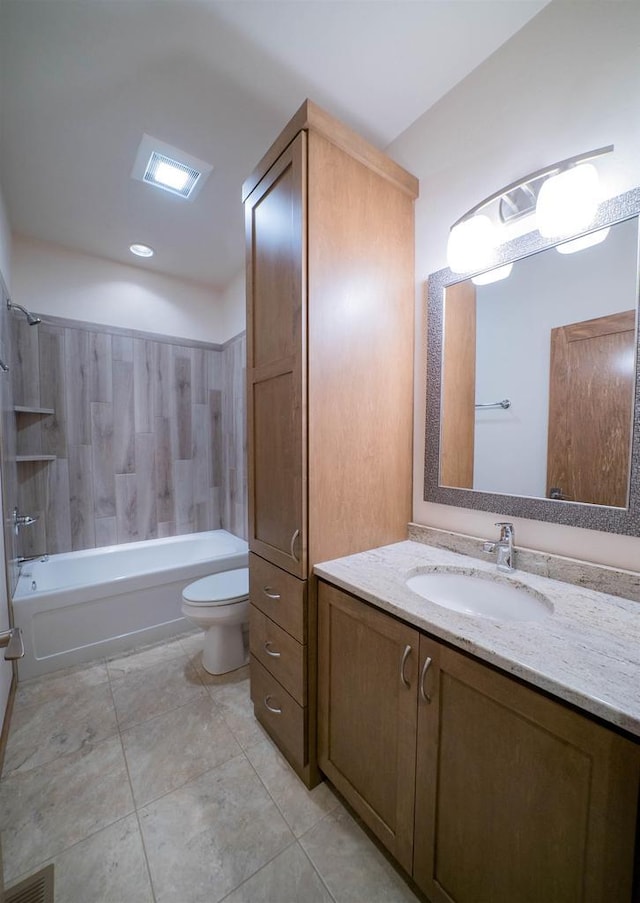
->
[318,581,640,903]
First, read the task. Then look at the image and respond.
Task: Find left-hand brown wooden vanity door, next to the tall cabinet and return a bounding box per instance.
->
[318,581,418,871]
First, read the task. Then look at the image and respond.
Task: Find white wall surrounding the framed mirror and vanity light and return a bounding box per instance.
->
[388,0,640,570]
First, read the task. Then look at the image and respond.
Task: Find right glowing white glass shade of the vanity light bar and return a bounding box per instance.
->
[536,163,600,238]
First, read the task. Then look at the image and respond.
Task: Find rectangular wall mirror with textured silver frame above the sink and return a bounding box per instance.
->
[425,190,640,535]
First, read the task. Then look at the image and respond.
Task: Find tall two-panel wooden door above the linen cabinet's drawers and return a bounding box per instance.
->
[245,132,307,577]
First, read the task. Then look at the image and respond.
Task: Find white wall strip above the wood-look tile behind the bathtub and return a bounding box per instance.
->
[11,236,230,343]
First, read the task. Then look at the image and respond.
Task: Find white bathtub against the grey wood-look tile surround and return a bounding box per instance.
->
[13,530,248,680]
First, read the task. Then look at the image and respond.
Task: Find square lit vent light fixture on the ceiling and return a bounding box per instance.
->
[131,135,213,200]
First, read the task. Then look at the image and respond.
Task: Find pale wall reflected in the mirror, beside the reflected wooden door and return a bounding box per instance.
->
[473,218,638,498]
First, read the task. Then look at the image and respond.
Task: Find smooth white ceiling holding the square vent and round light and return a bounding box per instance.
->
[0,0,548,289]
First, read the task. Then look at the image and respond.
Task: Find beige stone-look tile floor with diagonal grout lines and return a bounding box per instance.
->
[0,633,416,903]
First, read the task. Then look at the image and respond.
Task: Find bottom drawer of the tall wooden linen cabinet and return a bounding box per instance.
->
[251,655,307,768]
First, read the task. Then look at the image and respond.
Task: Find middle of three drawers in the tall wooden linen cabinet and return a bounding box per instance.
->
[249,605,307,705]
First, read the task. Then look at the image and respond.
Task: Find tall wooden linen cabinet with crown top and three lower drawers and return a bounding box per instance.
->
[243,101,418,786]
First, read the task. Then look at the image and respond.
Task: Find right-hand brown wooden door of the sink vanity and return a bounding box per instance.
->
[414,637,638,903]
